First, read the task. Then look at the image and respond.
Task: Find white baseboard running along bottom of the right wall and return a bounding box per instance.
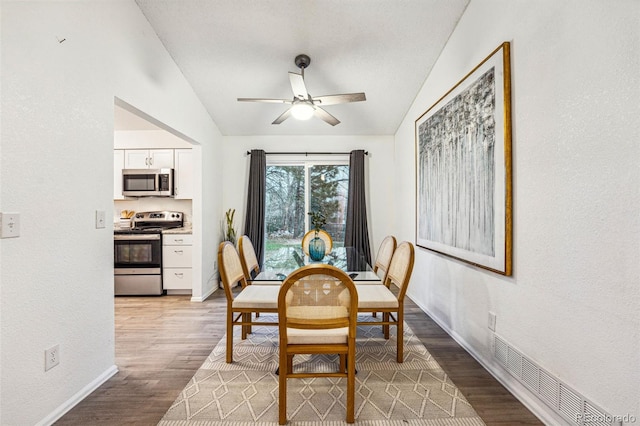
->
[407,295,570,426]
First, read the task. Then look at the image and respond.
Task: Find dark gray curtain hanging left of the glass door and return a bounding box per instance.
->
[244,149,267,268]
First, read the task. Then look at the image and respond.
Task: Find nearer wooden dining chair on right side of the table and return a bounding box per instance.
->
[357,241,415,363]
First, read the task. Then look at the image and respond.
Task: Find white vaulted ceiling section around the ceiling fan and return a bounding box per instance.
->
[130,0,469,135]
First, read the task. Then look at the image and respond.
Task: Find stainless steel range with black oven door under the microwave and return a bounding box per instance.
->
[113,211,184,296]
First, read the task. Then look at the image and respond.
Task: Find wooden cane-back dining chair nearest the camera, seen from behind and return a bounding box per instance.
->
[278,264,358,425]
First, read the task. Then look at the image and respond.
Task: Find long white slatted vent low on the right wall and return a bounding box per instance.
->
[493,333,622,426]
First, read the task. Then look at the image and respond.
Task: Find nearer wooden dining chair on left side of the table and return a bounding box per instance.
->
[218,241,280,363]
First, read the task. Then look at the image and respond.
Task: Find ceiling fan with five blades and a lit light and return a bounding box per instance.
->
[238,55,367,126]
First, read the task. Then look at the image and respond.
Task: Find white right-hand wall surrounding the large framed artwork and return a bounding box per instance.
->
[394,0,640,423]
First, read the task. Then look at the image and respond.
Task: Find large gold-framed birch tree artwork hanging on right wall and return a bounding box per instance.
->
[415,42,512,275]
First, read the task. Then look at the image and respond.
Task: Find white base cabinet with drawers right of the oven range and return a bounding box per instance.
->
[162,234,193,293]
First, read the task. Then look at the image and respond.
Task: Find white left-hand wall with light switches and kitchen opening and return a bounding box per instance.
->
[0,0,221,425]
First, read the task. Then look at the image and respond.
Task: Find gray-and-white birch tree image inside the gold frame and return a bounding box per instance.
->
[418,68,496,256]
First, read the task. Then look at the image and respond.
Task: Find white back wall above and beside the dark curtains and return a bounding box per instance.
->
[222,136,394,256]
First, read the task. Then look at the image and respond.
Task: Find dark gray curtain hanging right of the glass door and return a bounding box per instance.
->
[344,149,371,271]
